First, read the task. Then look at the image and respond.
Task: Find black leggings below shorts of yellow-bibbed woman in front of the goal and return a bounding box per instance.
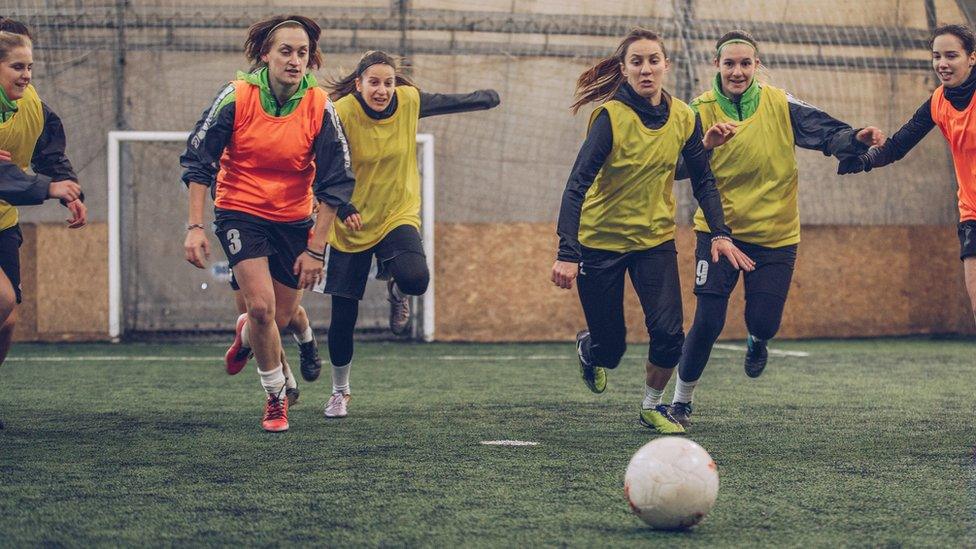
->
[329,252,430,366]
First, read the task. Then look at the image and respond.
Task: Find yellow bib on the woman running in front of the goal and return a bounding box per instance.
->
[330,86,420,253]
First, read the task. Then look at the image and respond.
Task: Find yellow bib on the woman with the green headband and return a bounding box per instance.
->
[692,86,800,248]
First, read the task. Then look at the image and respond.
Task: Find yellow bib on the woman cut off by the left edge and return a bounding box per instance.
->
[0,86,44,231]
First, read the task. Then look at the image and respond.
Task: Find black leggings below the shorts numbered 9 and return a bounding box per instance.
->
[678,293,786,382]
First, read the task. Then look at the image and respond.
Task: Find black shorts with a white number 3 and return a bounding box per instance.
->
[214,209,313,289]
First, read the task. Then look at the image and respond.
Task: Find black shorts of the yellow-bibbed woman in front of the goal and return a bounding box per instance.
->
[323,225,426,300]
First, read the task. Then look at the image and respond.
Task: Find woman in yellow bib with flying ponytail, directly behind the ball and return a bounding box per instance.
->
[552,28,753,433]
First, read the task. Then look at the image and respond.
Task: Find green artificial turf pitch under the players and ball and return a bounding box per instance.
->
[0,339,976,547]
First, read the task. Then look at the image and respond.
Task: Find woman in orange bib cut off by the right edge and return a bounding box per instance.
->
[838,25,976,326]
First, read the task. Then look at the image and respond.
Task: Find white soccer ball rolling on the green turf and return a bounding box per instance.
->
[624,437,718,529]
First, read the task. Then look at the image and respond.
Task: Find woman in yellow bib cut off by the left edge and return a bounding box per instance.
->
[0,25,87,428]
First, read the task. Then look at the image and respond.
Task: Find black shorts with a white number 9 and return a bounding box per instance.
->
[695,231,797,299]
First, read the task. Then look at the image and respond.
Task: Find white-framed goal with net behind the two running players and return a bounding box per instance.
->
[108,131,434,341]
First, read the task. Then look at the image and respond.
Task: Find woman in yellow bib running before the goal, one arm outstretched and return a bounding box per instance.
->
[324,51,499,418]
